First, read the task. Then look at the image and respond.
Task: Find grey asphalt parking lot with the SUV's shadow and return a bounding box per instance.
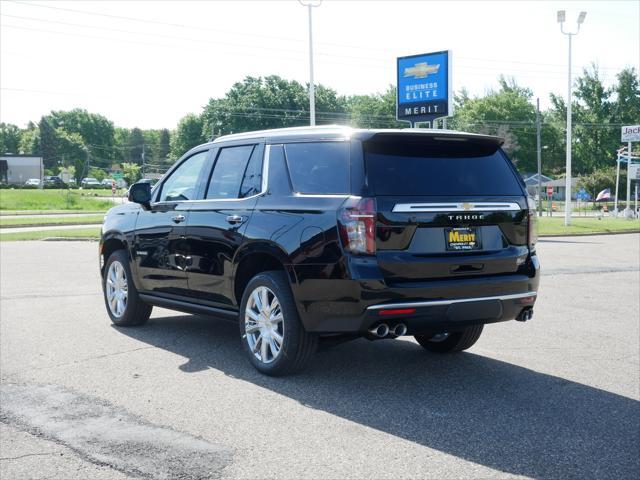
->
[0,234,640,479]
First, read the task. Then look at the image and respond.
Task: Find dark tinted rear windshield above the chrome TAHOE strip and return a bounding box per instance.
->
[365,143,523,195]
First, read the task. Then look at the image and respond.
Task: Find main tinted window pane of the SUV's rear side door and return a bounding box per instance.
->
[206,145,254,198]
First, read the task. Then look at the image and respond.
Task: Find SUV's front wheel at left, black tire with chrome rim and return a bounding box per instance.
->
[102,250,153,327]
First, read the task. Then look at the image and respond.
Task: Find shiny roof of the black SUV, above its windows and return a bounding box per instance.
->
[211,125,504,145]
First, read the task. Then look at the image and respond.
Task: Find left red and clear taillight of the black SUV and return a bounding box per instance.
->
[338,197,376,255]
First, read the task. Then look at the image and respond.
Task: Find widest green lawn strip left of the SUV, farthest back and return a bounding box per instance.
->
[0,189,114,212]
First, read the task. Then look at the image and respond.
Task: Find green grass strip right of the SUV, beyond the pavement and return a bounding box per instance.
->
[538,216,640,236]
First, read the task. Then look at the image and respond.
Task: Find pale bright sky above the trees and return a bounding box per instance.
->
[0,0,640,129]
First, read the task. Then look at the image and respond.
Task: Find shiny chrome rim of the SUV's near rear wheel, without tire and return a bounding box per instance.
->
[244,287,284,363]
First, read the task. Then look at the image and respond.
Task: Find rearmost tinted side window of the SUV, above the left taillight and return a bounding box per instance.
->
[284,142,349,194]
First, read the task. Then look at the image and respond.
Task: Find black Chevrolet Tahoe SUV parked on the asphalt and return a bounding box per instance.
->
[100,126,540,375]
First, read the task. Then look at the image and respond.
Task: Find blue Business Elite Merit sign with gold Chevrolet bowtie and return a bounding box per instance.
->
[396,51,453,122]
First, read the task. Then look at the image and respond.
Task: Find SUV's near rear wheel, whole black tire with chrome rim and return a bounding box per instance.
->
[239,271,318,377]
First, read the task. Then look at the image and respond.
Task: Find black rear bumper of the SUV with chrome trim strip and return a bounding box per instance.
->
[292,251,540,335]
